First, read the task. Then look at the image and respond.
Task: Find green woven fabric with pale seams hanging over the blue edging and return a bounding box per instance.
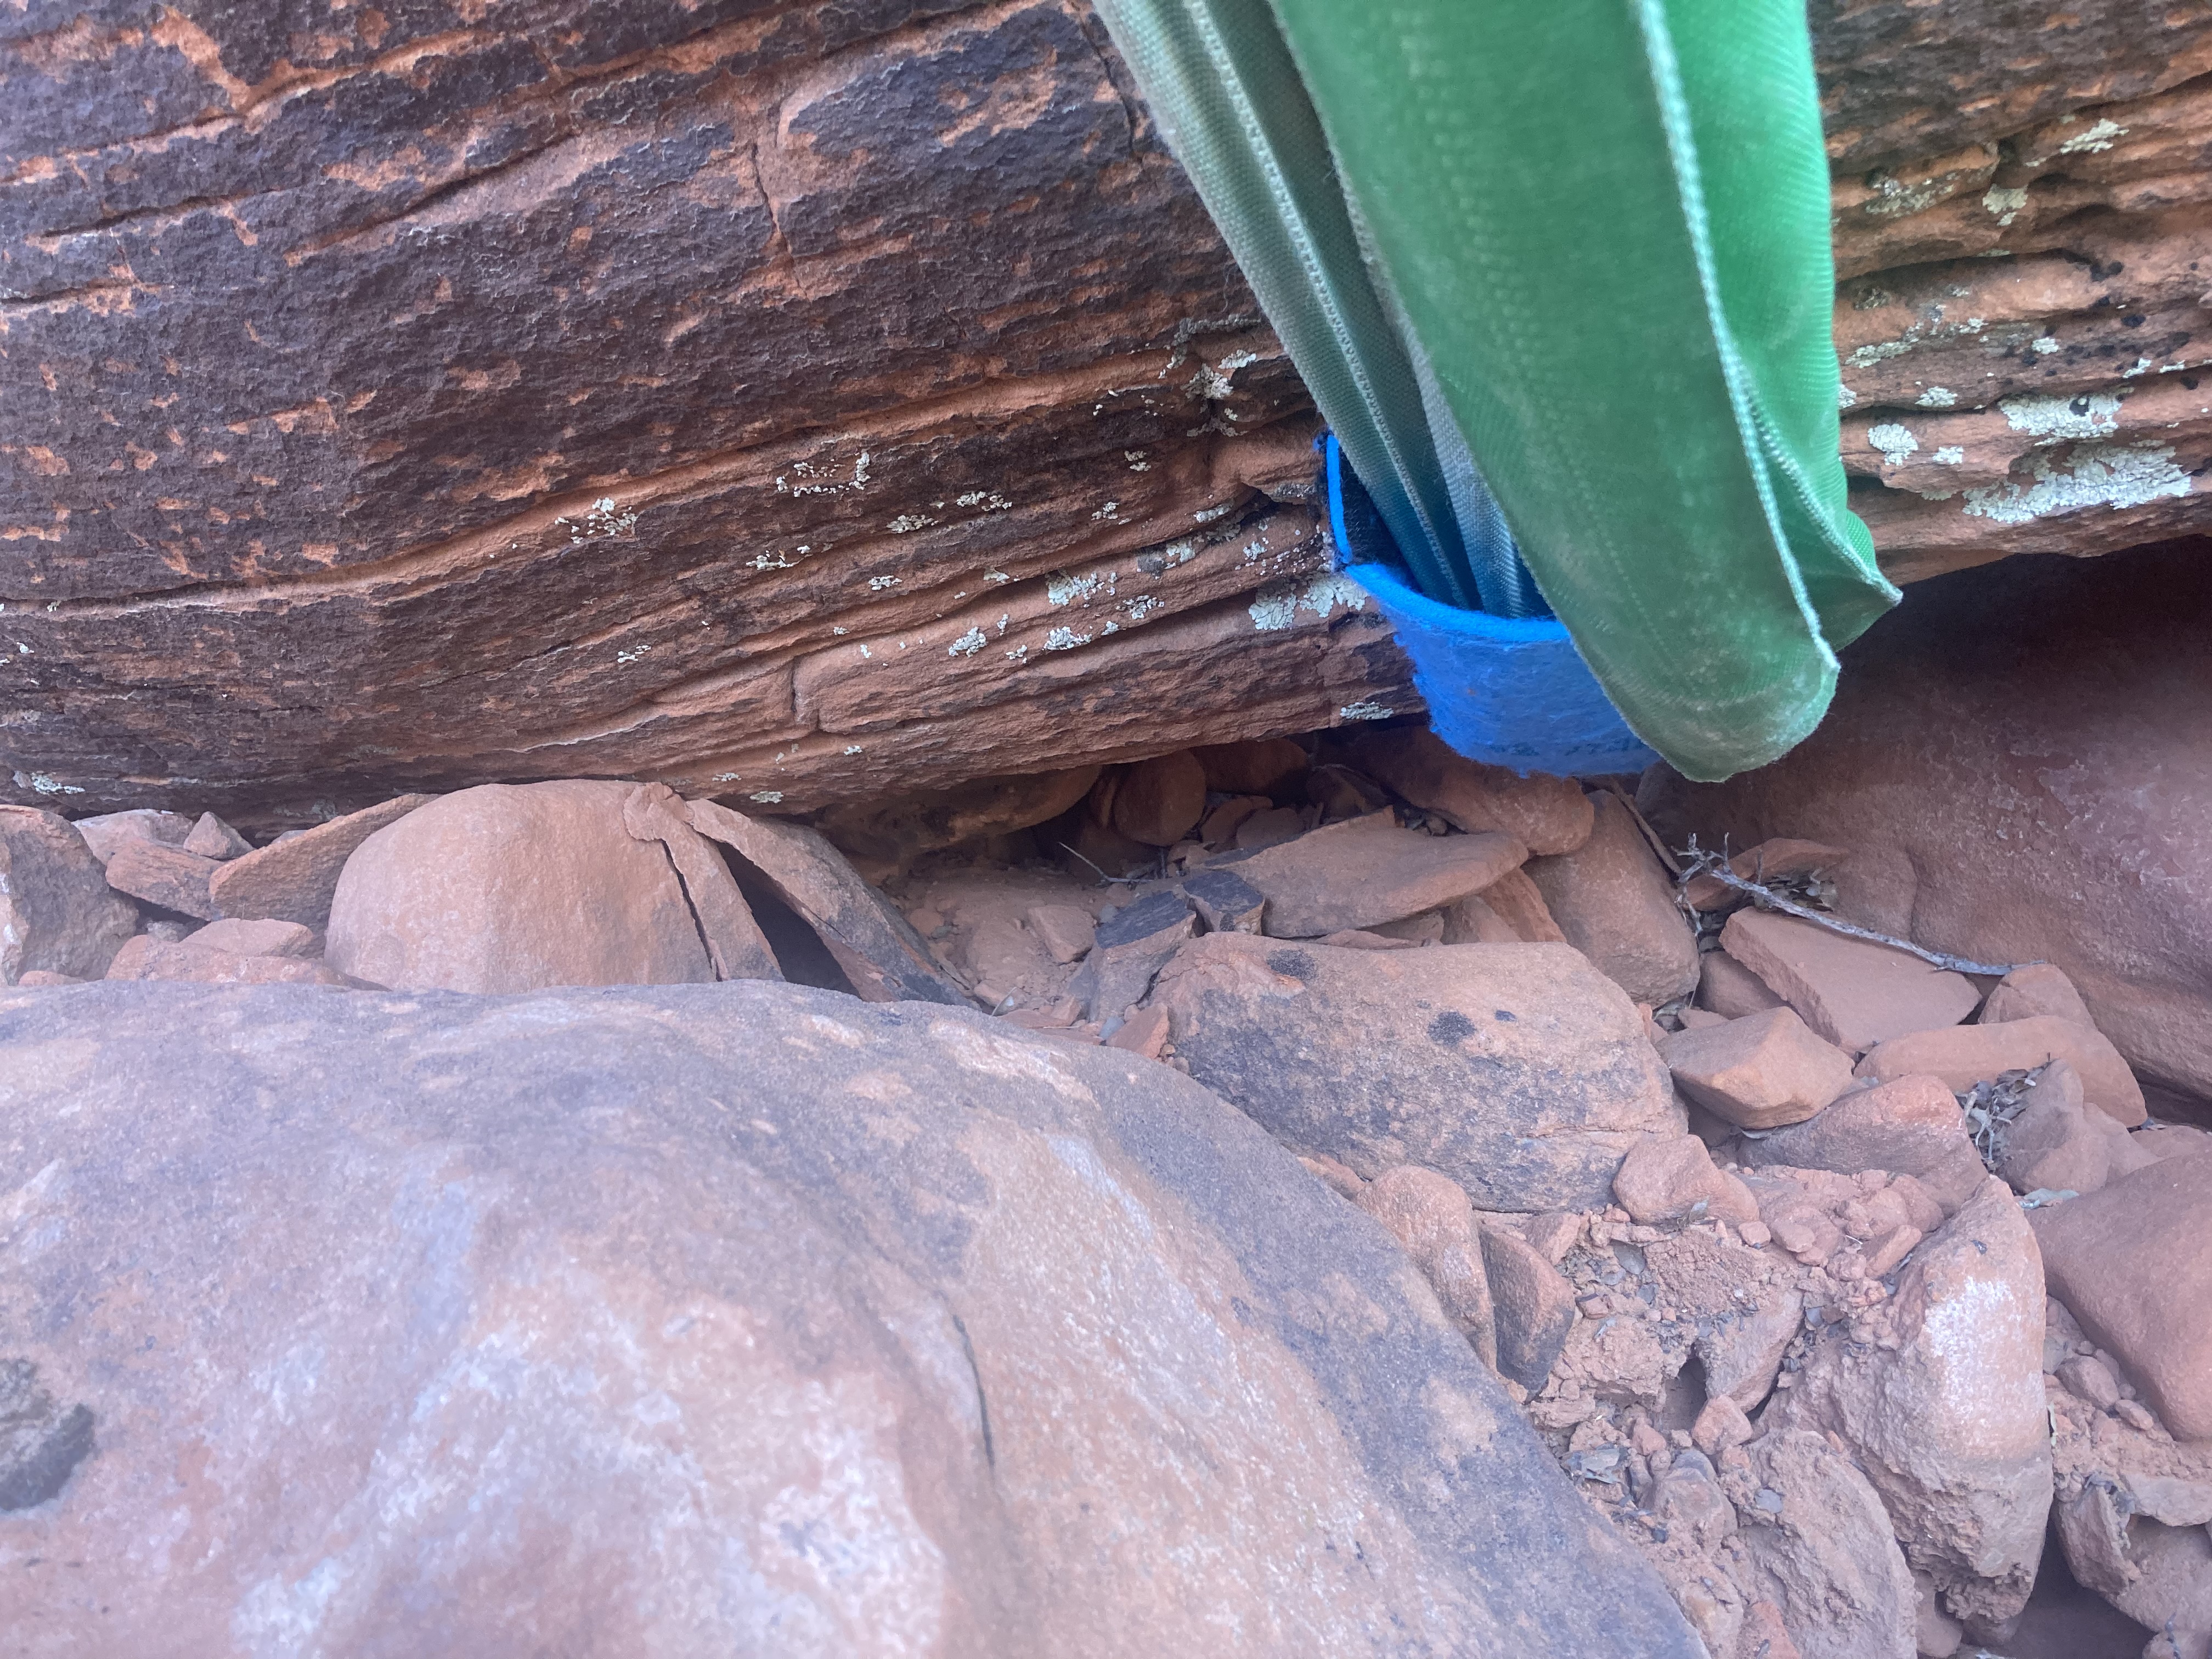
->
[1102,0,1898,778]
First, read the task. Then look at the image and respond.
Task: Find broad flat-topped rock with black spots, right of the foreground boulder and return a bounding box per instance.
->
[1155,934,1683,1210]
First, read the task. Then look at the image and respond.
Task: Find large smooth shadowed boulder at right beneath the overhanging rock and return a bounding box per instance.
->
[1644,544,2212,1104]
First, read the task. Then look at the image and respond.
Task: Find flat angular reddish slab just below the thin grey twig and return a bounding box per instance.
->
[1721,909,1982,1055]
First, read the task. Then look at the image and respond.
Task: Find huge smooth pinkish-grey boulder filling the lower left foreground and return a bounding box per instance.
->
[0,982,1699,1659]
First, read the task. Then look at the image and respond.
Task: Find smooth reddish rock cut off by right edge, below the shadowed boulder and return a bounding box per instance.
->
[2028,1155,2212,1440]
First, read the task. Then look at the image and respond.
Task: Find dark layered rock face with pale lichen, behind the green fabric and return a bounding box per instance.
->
[0,0,2212,821]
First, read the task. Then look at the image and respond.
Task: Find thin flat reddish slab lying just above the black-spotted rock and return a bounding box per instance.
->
[1228,812,1528,938]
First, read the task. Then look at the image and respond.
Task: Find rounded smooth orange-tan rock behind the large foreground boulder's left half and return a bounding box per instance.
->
[327,778,741,993]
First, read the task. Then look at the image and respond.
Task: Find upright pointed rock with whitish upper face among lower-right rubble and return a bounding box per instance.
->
[1765,1177,2051,1623]
